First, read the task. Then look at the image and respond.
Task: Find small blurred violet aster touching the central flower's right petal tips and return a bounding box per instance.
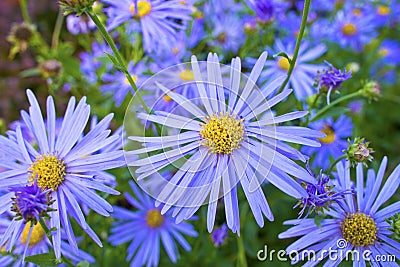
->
[301,115,353,170]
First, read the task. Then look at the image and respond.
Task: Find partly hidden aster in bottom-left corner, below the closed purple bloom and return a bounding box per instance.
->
[0,213,95,267]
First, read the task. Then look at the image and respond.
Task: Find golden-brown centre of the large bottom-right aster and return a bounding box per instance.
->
[340,212,378,247]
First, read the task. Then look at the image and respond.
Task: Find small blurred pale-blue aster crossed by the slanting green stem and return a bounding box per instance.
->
[100,61,147,106]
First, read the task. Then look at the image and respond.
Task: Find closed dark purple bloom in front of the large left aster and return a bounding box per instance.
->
[11,182,54,224]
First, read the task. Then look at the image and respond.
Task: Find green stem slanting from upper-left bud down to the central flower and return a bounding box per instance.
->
[85,9,151,114]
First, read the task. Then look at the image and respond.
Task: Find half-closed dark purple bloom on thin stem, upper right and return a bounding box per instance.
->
[316,61,351,105]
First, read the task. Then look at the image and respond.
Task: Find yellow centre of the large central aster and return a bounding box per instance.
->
[200,112,244,155]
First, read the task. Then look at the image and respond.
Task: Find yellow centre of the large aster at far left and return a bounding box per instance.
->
[28,154,67,191]
